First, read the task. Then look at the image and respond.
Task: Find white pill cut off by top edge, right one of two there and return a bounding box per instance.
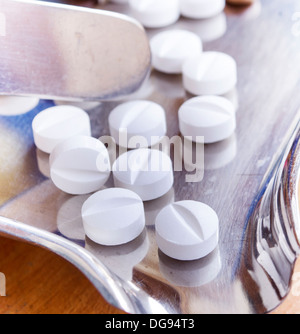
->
[180,0,226,19]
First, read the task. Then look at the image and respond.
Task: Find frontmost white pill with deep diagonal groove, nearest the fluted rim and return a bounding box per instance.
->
[155,201,219,261]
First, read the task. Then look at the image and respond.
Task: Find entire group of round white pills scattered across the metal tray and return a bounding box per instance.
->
[32,0,246,261]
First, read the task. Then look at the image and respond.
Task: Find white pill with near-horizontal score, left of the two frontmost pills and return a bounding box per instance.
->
[82,188,145,246]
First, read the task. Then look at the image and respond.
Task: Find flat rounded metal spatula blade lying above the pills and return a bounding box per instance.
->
[0,0,151,100]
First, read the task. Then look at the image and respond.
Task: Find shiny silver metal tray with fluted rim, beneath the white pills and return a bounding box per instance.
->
[0,0,300,314]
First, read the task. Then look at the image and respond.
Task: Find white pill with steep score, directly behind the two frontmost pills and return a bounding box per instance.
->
[112,149,174,201]
